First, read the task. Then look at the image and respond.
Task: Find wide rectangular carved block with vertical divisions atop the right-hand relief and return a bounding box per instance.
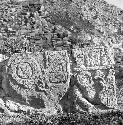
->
[73,46,114,70]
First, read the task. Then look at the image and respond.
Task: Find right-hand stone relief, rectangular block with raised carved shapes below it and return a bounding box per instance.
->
[73,46,117,107]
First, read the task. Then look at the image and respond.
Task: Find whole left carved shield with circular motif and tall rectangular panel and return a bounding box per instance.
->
[4,51,70,112]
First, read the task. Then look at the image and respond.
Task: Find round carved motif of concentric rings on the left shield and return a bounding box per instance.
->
[8,54,41,88]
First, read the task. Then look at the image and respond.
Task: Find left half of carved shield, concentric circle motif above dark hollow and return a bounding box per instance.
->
[8,53,54,109]
